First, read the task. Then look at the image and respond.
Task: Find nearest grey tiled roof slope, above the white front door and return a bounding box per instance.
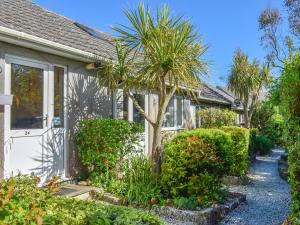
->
[0,0,115,58]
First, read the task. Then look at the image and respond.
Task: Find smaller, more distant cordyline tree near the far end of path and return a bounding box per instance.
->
[227,49,271,128]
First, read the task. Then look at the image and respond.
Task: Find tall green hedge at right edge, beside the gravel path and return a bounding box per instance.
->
[278,54,300,224]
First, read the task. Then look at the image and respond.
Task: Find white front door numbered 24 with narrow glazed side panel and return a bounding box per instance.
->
[4,57,65,182]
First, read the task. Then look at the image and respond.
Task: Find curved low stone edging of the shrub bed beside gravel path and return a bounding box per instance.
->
[151,193,246,225]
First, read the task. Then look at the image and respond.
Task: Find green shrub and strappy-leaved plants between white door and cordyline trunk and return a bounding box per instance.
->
[76,119,161,205]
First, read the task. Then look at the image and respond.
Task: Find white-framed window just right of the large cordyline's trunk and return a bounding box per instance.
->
[163,97,183,127]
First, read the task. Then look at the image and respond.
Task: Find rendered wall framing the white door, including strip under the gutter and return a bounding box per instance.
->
[0,42,112,177]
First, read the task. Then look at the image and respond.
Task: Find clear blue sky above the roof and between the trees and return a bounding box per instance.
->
[33,0,284,85]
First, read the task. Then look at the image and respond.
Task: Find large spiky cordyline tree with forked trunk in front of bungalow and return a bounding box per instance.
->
[98,4,207,173]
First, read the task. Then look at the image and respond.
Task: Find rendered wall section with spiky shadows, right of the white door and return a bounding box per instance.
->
[67,74,112,177]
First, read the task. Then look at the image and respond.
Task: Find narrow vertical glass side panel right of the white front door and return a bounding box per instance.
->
[53,66,64,127]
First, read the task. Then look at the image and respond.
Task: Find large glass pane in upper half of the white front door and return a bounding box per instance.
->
[11,64,44,130]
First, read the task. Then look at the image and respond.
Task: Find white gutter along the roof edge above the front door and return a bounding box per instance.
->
[0,26,109,62]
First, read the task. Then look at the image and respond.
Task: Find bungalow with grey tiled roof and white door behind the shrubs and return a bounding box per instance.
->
[0,0,244,180]
